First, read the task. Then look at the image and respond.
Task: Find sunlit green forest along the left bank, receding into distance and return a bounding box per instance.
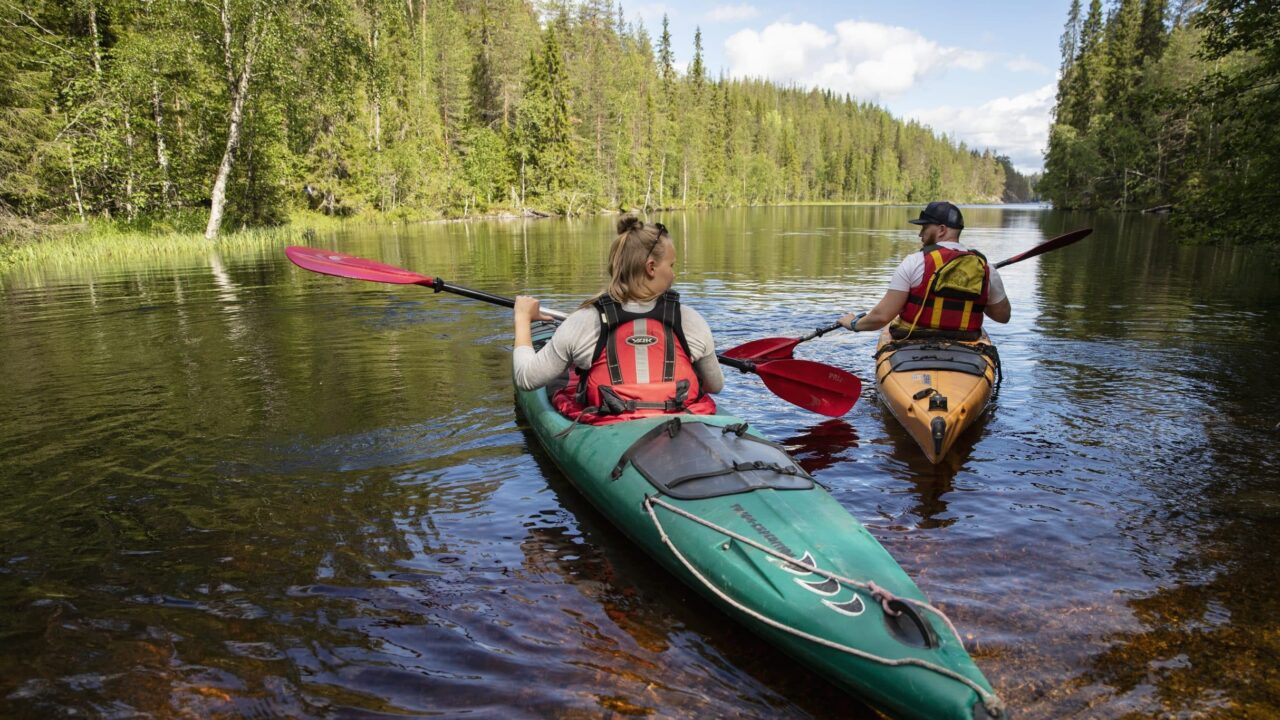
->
[0,0,1030,238]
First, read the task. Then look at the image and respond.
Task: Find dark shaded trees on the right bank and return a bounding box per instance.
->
[1037,0,1280,243]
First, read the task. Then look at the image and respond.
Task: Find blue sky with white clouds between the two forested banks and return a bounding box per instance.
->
[622,0,1070,172]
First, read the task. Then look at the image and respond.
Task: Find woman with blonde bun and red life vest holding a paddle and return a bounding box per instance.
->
[512,215,724,424]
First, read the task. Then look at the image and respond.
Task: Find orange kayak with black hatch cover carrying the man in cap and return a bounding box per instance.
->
[876,329,1000,464]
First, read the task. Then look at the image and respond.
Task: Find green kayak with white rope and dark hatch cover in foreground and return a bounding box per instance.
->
[516,323,1005,720]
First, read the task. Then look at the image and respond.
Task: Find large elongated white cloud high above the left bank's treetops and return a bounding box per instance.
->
[724,20,991,100]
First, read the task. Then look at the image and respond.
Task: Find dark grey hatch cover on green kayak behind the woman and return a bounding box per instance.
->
[613,418,814,500]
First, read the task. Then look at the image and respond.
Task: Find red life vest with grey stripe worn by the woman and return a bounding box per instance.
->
[552,291,716,425]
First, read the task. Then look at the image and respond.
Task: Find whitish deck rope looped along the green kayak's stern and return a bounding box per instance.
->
[644,496,1005,717]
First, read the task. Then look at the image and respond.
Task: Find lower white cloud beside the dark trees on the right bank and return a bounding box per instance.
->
[908,82,1057,173]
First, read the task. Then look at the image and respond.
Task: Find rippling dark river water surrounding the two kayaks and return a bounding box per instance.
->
[0,206,1280,719]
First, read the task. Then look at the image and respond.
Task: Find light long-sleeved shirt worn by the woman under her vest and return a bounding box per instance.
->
[511,300,724,392]
